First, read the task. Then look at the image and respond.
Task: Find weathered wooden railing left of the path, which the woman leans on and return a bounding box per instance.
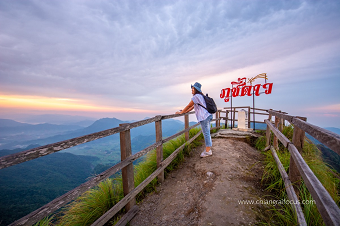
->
[0,111,220,225]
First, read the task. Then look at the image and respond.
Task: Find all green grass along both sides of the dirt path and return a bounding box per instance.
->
[36,123,340,225]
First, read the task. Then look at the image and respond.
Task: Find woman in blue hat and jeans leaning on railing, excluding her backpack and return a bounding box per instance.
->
[176,82,213,158]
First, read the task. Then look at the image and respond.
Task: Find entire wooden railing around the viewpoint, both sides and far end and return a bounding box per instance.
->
[0,107,340,225]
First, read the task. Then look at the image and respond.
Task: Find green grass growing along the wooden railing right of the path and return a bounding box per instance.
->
[255,126,340,225]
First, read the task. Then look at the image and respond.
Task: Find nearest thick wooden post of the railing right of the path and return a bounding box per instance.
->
[289,117,307,190]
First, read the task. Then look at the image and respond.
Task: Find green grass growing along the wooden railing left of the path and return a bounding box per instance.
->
[49,128,203,226]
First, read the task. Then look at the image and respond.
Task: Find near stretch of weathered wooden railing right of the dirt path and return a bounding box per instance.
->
[264,110,340,225]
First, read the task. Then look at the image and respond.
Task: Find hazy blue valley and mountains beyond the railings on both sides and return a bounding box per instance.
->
[0,116,340,225]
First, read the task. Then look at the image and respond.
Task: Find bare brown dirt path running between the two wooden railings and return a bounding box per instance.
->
[130,133,265,226]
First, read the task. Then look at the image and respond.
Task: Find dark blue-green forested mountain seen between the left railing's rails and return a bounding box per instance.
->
[0,150,97,225]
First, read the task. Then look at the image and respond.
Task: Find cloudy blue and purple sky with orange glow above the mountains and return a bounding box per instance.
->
[0,0,340,128]
